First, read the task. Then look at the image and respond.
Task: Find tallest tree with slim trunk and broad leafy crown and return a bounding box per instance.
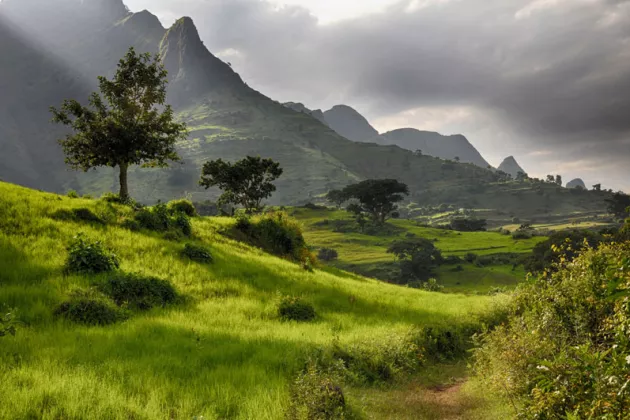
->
[50,48,187,200]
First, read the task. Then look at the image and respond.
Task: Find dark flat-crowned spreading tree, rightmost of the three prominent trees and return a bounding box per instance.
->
[343,179,409,225]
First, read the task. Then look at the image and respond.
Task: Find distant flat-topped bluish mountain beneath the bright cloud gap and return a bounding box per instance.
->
[382,128,490,168]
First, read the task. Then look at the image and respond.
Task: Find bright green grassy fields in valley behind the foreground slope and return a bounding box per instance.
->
[291,208,544,292]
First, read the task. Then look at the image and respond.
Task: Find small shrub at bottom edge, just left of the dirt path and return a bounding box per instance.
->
[287,364,347,420]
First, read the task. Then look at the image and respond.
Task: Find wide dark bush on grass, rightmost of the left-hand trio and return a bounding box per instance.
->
[98,273,177,311]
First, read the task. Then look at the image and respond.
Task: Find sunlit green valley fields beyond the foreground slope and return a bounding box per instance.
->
[291,208,545,293]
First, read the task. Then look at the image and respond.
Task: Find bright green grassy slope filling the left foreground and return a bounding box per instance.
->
[0,183,504,419]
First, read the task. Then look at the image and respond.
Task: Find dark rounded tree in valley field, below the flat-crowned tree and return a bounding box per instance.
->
[387,238,444,283]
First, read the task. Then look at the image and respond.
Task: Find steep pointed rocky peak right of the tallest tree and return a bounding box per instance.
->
[160,17,246,105]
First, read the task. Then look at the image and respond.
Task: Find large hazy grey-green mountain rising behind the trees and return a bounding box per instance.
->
[0,0,612,221]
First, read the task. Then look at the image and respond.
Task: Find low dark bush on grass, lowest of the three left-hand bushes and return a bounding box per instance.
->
[54,290,128,325]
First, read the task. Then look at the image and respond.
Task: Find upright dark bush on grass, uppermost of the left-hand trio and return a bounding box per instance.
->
[65,233,120,274]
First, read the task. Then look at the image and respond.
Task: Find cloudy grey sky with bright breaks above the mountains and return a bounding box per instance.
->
[126,0,630,191]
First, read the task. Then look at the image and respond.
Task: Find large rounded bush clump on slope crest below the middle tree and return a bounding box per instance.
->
[235,212,315,264]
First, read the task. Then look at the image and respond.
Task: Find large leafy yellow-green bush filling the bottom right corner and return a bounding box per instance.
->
[475,244,630,419]
